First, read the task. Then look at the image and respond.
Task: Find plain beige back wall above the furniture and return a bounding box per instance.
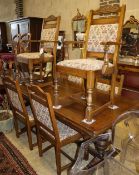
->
[0,0,139,30]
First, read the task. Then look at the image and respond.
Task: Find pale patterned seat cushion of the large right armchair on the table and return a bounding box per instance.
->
[57,58,112,71]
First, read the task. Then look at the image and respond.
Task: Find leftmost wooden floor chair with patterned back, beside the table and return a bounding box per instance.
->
[3,77,35,150]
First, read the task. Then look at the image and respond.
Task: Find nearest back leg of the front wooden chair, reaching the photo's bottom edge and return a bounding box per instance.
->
[55,146,61,175]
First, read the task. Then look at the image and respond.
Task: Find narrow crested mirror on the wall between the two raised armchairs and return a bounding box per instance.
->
[72,9,86,48]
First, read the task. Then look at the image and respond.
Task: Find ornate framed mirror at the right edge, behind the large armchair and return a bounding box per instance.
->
[120,16,139,57]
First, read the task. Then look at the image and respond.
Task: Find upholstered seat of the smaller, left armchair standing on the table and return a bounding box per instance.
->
[17,52,53,63]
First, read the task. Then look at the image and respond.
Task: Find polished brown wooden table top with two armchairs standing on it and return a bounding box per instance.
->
[21,80,137,136]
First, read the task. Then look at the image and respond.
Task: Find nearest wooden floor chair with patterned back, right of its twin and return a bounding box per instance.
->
[28,85,81,175]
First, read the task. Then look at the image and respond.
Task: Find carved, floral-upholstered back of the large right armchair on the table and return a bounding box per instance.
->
[83,5,125,64]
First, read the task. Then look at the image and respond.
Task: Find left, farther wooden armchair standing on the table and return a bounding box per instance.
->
[17,15,61,81]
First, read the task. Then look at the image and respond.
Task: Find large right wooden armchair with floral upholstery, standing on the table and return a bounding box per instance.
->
[57,5,126,123]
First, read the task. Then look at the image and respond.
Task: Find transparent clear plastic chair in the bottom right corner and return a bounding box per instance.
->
[69,109,139,175]
